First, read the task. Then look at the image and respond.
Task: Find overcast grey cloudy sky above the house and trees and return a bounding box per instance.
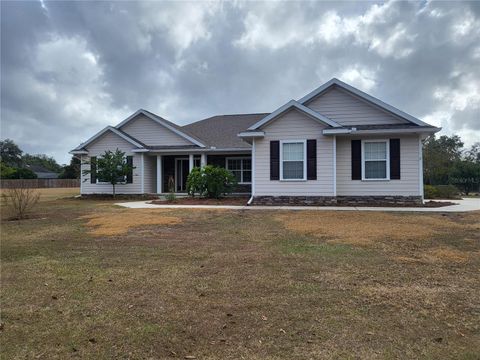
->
[1,1,480,162]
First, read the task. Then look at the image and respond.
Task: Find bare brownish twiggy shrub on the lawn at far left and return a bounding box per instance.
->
[2,180,40,220]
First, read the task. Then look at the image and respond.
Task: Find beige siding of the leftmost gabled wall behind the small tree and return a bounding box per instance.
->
[81,131,142,194]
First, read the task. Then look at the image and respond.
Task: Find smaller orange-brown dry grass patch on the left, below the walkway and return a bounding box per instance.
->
[82,209,181,236]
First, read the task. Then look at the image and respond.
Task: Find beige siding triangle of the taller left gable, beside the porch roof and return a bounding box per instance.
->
[120,116,192,146]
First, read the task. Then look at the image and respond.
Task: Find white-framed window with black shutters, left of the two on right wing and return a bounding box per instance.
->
[280,140,307,181]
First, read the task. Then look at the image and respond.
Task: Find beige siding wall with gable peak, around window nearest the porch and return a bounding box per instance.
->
[253,110,333,196]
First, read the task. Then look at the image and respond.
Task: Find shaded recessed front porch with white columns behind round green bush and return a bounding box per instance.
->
[140,152,252,195]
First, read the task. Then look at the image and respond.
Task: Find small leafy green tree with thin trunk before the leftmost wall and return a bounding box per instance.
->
[82,149,135,197]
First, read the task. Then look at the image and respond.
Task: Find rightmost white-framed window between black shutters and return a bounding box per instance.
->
[362,139,390,180]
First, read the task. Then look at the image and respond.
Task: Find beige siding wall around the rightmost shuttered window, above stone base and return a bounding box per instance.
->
[337,136,420,196]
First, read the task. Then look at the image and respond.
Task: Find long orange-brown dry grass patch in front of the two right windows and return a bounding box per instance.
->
[277,212,479,246]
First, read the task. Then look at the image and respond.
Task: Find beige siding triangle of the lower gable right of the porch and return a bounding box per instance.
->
[262,108,328,137]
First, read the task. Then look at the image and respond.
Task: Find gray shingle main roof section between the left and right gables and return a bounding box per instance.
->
[180,113,268,149]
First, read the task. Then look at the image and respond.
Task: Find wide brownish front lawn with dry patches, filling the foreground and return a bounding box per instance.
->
[0,190,480,359]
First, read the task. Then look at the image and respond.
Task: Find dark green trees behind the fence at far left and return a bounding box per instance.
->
[0,139,80,179]
